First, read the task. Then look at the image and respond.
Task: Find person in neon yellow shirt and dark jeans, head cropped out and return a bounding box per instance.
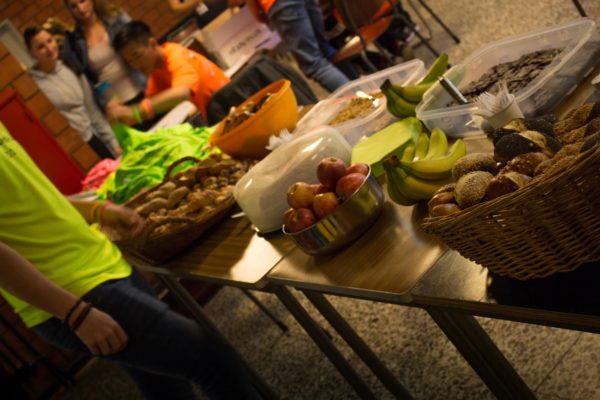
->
[0,123,260,400]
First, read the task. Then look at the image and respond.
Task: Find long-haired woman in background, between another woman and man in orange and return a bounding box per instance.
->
[62,0,145,109]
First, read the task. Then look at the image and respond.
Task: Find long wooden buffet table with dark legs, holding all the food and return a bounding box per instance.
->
[131,59,600,399]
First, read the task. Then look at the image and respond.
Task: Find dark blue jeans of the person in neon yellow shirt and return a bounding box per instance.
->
[34,272,260,400]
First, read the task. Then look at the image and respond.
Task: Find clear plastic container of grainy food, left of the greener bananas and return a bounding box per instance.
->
[295,59,425,145]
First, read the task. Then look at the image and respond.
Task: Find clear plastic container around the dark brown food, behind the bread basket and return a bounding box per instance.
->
[417,18,600,137]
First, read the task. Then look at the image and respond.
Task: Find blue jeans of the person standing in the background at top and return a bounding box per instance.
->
[269,0,348,91]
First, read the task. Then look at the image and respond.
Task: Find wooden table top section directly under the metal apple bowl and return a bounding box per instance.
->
[267,195,444,303]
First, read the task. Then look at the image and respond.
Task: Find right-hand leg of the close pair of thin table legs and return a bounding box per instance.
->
[302,290,412,399]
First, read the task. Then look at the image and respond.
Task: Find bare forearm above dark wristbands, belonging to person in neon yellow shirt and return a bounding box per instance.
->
[0,243,77,319]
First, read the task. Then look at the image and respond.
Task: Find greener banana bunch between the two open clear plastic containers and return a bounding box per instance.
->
[380,53,448,118]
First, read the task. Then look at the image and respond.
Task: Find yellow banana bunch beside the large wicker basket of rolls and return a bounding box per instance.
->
[383,128,466,206]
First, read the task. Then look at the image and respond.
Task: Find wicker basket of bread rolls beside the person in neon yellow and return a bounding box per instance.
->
[106,154,252,264]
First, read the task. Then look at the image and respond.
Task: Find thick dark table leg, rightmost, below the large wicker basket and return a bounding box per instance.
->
[425,307,535,400]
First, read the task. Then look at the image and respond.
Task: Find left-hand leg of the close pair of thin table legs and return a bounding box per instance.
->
[272,286,376,399]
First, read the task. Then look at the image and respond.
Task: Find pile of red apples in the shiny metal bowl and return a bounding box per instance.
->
[283,157,369,233]
